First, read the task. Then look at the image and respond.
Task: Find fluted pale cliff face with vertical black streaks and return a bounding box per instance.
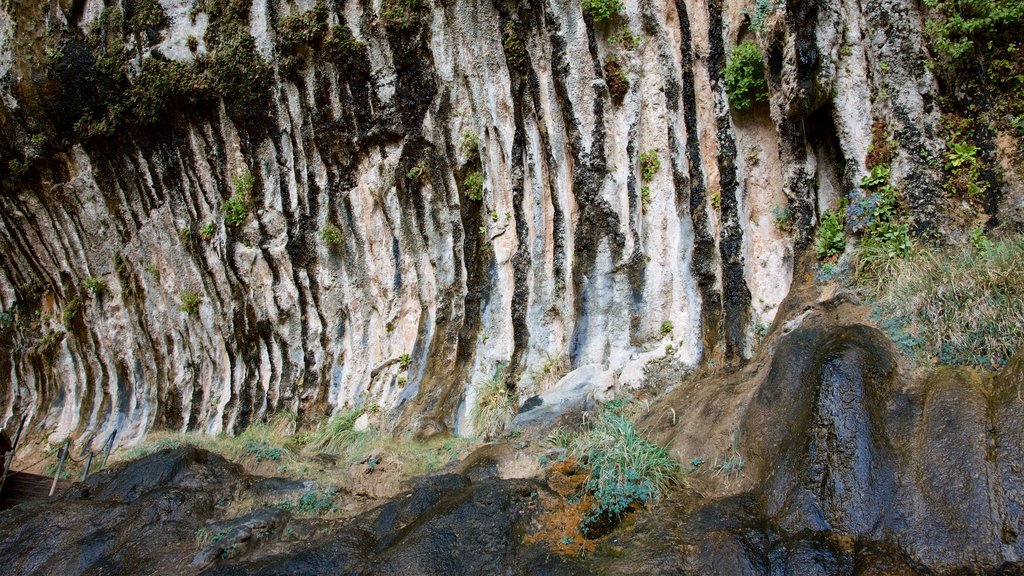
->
[0,0,949,442]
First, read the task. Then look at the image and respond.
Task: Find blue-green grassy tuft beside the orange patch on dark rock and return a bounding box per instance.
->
[569,406,681,535]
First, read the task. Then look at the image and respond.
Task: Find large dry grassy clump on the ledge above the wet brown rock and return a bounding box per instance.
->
[862,239,1024,368]
